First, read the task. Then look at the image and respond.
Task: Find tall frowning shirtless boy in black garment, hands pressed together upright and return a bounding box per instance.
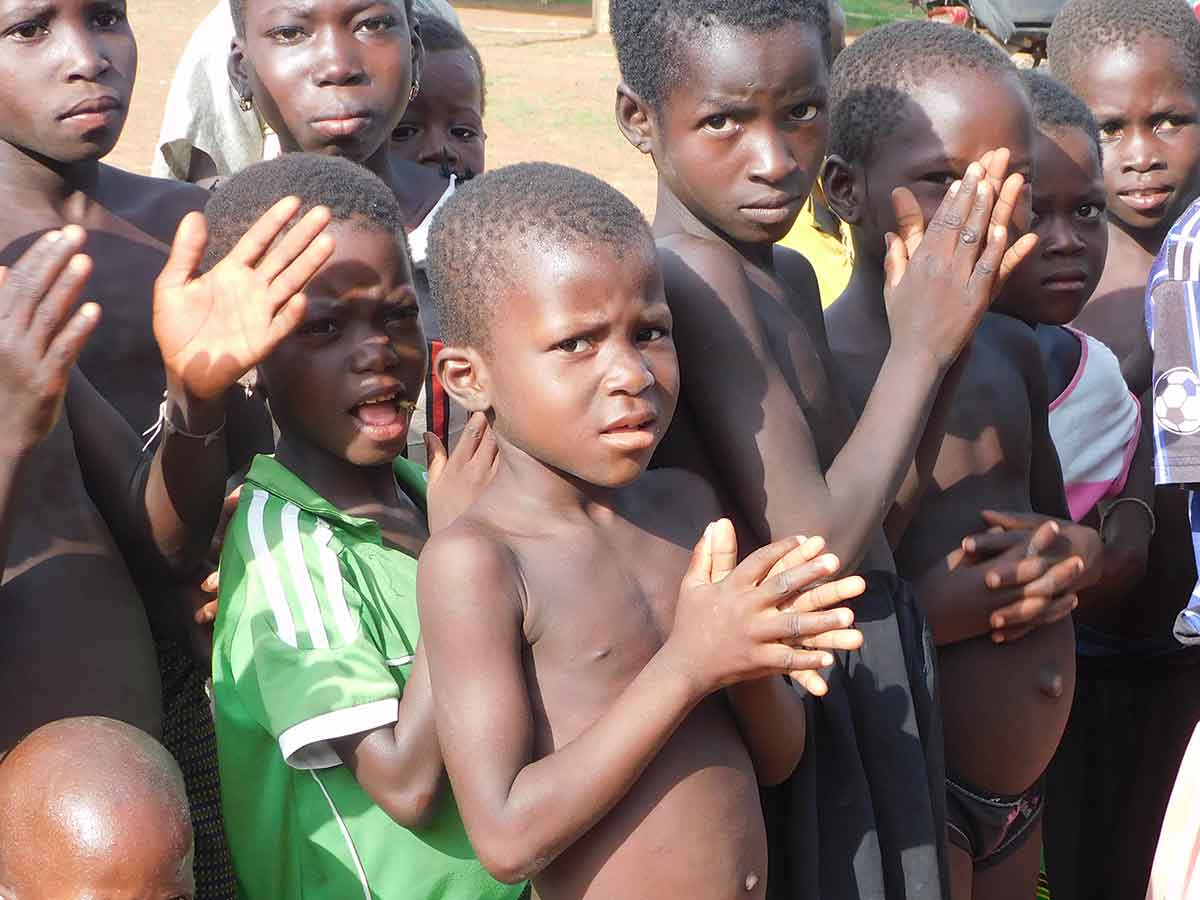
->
[612,0,1060,896]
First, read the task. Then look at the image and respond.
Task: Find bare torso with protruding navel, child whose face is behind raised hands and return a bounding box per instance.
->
[832,309,1075,794]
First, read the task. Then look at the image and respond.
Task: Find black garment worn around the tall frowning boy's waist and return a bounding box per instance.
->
[762,572,950,900]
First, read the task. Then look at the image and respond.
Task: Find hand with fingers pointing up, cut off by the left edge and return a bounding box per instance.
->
[0,226,100,452]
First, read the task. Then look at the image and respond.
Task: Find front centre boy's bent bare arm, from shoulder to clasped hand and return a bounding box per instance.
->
[418,526,852,883]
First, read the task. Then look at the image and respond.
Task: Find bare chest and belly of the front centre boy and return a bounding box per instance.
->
[476,473,767,900]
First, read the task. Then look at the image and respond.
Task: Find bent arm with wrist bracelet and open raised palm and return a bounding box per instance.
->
[68,198,332,572]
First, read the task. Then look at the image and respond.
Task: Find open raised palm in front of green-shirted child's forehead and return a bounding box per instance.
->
[154,197,334,401]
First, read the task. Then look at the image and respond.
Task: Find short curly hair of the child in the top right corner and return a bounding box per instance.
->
[1046,0,1200,94]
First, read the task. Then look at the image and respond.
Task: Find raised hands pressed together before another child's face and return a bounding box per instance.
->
[884,149,1037,372]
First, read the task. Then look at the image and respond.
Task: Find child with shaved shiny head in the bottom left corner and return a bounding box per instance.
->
[0,718,194,900]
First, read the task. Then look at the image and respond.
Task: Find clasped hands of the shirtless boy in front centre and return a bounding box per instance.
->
[662,520,865,695]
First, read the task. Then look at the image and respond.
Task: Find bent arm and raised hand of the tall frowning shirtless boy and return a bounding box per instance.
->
[662,163,1028,569]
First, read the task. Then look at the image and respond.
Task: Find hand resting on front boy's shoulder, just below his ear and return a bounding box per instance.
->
[425,413,500,534]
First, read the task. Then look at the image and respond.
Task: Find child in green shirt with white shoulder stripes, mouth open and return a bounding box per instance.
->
[206,154,521,900]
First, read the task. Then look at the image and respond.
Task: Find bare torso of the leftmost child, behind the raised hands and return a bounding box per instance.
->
[0,167,203,751]
